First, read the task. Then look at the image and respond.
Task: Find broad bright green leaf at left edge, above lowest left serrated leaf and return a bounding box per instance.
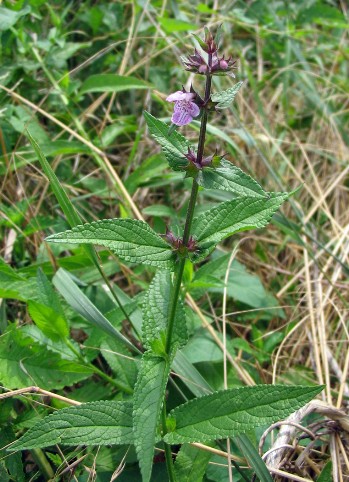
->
[0,328,93,390]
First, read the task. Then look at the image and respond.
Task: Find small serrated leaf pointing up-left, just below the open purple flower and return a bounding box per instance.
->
[144,111,190,171]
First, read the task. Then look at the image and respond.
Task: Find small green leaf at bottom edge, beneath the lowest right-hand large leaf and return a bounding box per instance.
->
[174,444,212,482]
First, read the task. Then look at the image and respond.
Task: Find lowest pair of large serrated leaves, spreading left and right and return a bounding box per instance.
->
[8,384,323,451]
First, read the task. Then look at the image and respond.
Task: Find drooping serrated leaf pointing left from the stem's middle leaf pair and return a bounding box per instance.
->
[46,219,174,269]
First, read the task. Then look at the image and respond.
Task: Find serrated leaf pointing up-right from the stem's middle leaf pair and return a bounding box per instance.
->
[192,193,289,246]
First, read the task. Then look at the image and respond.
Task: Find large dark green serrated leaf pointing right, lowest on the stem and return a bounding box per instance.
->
[164,385,323,444]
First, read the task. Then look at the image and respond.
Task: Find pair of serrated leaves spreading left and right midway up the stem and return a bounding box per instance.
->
[47,193,289,270]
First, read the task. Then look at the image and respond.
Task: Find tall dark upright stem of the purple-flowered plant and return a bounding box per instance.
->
[162,54,212,482]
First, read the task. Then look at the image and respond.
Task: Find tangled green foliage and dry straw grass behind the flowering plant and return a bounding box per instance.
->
[0,0,349,482]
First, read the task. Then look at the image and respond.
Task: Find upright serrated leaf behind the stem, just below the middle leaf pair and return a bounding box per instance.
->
[142,271,188,349]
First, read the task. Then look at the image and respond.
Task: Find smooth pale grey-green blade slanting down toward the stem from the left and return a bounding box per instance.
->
[53,268,138,352]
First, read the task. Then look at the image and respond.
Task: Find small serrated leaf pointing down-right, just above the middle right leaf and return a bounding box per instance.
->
[196,159,268,199]
